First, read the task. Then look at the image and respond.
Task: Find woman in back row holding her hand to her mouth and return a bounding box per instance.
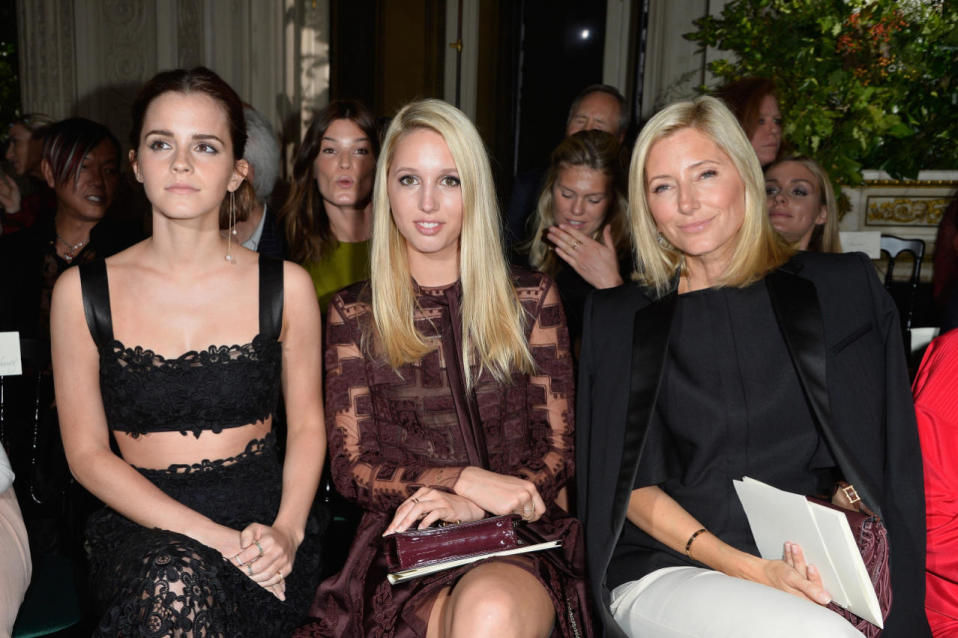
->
[527,130,632,351]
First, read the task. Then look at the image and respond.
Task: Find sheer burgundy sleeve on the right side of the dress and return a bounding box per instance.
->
[518,276,575,503]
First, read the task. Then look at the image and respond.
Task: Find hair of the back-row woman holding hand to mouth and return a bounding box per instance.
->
[526,131,629,276]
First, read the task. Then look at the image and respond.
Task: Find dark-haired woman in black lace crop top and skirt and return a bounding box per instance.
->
[51,67,325,637]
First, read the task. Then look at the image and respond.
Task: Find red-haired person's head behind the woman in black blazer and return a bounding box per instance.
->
[714,78,782,168]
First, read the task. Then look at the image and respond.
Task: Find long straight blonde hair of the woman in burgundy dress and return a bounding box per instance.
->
[370,99,534,388]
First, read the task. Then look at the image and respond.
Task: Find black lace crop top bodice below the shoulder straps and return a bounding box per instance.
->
[100,334,282,437]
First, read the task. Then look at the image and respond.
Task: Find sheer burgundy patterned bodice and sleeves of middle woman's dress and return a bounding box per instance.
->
[325,272,574,513]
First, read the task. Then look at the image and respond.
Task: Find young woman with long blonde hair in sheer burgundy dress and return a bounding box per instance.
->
[313,100,586,637]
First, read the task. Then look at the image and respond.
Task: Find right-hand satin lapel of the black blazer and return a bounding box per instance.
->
[765,269,882,518]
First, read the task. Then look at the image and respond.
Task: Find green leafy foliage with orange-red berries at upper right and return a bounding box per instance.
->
[685,0,958,185]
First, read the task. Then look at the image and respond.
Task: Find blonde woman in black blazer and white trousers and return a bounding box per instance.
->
[576,97,928,638]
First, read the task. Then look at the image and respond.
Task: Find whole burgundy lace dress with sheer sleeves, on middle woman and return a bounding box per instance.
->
[308,273,585,637]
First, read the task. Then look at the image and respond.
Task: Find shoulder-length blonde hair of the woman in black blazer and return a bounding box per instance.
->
[629,96,794,294]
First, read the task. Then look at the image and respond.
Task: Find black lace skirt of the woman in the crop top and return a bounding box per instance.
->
[87,434,325,638]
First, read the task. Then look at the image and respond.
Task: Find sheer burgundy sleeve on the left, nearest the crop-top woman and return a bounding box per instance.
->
[325,293,464,513]
